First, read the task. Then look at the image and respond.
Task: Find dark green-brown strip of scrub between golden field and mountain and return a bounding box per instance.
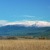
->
[0,36,50,40]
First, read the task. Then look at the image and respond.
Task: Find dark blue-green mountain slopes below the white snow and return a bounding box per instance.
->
[0,25,50,36]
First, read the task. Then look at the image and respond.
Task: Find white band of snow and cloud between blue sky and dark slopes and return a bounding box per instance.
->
[0,20,50,27]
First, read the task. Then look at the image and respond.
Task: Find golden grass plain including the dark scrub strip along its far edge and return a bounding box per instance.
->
[0,36,50,50]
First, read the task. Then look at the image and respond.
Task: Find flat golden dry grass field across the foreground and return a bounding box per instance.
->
[0,39,50,50]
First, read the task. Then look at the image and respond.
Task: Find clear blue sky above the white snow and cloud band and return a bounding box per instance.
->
[0,0,50,22]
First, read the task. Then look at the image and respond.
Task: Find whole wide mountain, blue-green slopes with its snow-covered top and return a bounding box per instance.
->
[0,22,50,38]
